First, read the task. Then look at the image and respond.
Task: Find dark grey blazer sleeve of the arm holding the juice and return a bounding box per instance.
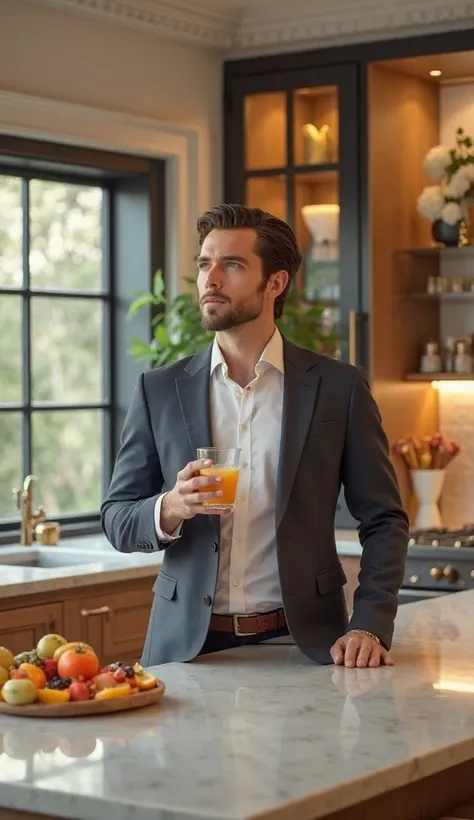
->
[101,374,166,552]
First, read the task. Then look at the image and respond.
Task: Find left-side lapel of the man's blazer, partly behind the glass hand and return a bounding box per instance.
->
[176,345,220,537]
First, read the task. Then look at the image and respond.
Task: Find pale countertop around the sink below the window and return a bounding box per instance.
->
[0,535,162,599]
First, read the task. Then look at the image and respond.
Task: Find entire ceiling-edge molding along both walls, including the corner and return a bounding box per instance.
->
[26,0,474,57]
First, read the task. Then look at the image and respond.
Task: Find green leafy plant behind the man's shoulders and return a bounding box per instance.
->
[129,270,339,368]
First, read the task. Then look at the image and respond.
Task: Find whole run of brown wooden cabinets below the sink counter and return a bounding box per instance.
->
[0,576,155,663]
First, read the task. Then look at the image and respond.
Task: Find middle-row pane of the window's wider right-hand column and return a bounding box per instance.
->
[31,296,104,404]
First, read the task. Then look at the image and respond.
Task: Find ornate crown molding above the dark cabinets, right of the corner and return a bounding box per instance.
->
[234,0,474,53]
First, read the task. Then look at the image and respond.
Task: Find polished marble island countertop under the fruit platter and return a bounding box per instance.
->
[0,591,474,820]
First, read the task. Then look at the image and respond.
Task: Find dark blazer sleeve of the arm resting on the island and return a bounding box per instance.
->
[342,370,408,648]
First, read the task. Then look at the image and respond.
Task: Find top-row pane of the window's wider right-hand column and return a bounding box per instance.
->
[30,179,102,290]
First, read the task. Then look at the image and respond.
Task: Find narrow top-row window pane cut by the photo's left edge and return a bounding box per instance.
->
[0,175,23,288]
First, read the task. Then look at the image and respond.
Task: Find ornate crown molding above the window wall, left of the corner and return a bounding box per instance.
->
[26,0,241,50]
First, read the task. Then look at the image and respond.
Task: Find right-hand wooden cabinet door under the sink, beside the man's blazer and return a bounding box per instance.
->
[65,584,153,663]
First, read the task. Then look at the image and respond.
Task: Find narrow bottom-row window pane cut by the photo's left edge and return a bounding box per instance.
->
[0,412,23,518]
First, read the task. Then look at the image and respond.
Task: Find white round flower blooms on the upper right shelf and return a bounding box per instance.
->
[417,128,474,225]
